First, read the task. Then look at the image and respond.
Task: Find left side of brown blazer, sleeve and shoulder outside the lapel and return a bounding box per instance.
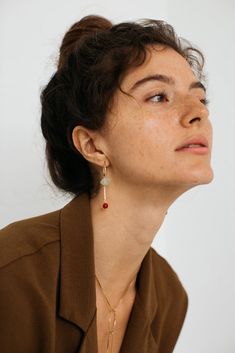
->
[0,221,81,353]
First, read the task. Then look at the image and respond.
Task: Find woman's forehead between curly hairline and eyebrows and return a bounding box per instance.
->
[122,45,196,91]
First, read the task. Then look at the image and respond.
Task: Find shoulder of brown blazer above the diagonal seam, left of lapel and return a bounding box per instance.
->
[0,210,60,268]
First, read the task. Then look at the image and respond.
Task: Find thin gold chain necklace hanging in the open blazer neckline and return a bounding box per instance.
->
[95,275,136,353]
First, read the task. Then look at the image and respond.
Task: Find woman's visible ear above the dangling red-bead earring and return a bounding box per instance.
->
[72,125,109,167]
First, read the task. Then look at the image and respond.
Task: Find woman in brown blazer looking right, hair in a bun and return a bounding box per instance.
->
[0,16,213,353]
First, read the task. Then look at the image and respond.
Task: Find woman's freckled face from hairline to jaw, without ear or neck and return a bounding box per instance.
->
[101,46,213,189]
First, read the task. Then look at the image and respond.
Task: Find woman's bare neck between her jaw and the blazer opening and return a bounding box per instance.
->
[90,180,187,302]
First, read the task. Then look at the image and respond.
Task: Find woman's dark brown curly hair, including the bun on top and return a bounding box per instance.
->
[41,15,204,197]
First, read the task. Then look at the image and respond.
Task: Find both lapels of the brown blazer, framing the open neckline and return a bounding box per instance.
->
[59,193,158,353]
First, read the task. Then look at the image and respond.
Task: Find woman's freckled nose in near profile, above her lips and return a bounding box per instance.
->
[180,97,209,127]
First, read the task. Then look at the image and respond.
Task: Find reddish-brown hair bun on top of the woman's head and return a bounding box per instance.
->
[58,15,112,69]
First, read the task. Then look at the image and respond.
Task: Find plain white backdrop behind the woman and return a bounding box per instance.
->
[0,0,235,353]
